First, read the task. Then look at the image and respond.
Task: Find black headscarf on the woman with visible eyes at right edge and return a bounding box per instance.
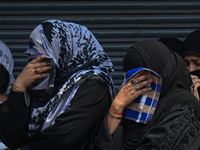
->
[182,30,200,57]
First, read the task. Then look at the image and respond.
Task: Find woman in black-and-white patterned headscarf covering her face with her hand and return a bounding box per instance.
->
[0,20,114,150]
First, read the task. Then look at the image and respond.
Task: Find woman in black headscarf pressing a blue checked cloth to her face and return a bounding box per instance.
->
[93,40,200,150]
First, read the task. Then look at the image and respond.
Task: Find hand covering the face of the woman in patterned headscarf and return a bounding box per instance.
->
[12,55,51,92]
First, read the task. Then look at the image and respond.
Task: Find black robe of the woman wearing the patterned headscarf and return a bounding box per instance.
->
[0,80,111,150]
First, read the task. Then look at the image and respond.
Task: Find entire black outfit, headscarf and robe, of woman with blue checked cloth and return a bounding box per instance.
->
[94,40,200,150]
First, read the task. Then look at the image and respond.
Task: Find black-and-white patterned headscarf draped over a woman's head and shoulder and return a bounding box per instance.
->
[26,20,115,132]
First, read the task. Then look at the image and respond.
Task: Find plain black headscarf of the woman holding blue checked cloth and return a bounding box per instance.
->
[123,40,200,148]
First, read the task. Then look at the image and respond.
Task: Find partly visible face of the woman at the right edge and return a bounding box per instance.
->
[184,54,200,72]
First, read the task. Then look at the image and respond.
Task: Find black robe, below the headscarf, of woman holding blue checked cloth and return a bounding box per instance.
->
[92,103,200,150]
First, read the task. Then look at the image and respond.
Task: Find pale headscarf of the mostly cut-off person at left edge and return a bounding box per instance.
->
[0,40,15,94]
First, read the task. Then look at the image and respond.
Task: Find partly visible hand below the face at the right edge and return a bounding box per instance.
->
[191,75,200,101]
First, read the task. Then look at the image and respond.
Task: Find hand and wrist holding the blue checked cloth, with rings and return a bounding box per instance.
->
[107,71,153,135]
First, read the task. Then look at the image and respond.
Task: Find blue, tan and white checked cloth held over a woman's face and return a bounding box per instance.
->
[122,67,162,124]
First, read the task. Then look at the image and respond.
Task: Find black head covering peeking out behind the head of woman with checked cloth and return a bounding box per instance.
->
[158,37,182,55]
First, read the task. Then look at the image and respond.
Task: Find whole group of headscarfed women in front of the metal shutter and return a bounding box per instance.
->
[0,20,200,150]
